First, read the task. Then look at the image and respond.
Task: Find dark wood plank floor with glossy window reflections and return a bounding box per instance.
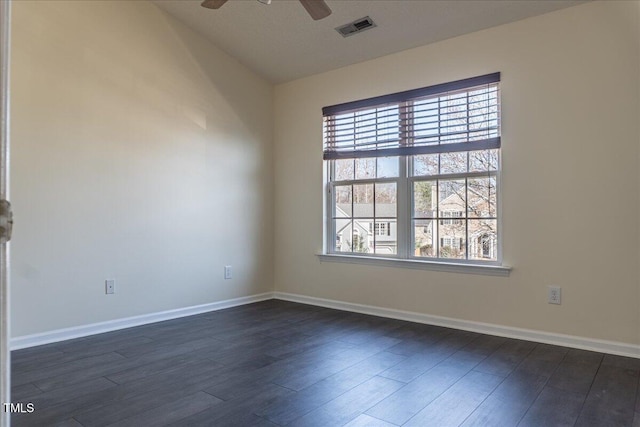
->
[12,300,640,427]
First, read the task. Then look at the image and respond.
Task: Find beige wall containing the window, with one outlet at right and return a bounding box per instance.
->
[274,2,640,344]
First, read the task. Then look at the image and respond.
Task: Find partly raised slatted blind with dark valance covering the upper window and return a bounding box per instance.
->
[322,73,500,160]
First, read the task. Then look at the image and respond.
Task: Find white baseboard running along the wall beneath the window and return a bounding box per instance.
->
[273,292,640,358]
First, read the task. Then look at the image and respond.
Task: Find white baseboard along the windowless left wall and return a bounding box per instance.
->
[10,292,273,350]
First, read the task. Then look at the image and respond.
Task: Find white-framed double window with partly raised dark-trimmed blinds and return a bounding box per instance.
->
[323,73,501,264]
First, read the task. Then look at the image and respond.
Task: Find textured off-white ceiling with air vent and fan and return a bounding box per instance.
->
[154,0,583,83]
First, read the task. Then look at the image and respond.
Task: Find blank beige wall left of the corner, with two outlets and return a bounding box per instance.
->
[11,1,273,337]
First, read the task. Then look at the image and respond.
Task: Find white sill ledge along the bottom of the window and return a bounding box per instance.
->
[318,254,511,277]
